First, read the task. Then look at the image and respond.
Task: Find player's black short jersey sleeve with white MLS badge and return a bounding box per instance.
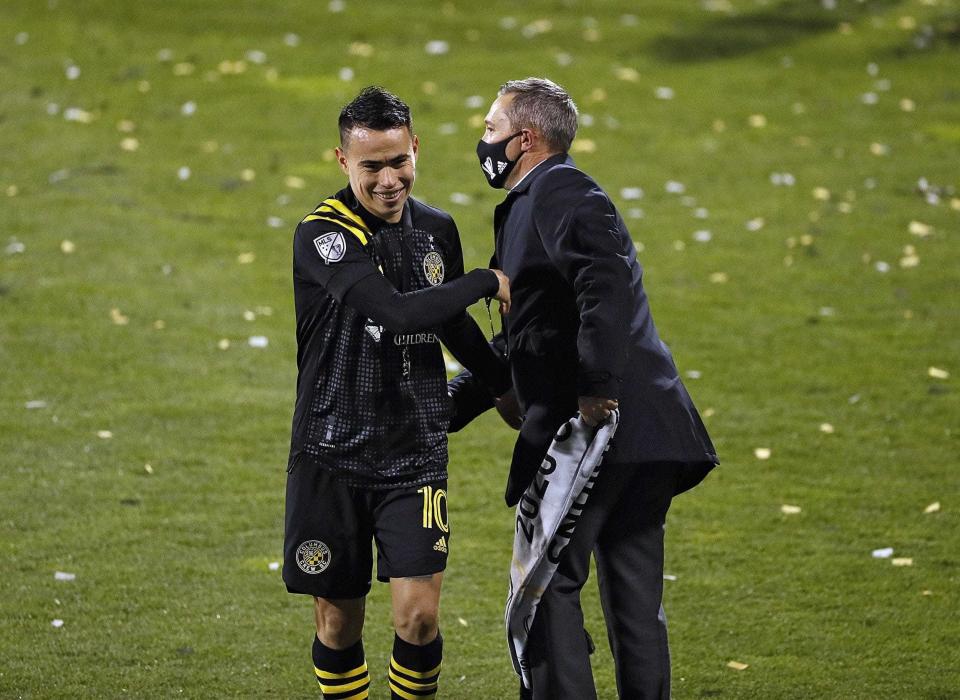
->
[293,220,379,302]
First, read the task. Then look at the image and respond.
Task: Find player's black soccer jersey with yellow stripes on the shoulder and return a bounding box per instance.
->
[290,187,497,488]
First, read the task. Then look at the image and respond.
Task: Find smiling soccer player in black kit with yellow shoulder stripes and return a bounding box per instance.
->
[283,87,510,700]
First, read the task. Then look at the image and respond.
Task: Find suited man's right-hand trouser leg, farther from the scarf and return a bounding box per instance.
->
[595,463,678,700]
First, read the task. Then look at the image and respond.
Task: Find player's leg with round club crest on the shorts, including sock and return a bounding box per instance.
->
[283,462,373,700]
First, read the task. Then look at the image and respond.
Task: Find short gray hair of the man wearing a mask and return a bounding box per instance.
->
[497,78,577,153]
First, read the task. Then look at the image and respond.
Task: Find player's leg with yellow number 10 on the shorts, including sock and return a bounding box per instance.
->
[374,480,450,700]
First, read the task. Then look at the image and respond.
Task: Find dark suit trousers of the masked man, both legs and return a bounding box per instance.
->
[522,462,680,700]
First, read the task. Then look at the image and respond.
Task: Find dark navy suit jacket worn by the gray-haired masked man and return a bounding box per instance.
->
[491,154,718,503]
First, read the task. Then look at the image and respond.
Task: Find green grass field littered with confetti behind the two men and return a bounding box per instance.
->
[0,0,960,699]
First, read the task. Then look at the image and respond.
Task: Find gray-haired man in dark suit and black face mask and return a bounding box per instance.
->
[477,78,717,700]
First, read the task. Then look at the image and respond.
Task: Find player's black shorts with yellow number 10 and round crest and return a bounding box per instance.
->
[283,459,450,598]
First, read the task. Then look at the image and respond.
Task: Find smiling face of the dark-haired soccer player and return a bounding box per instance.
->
[337,127,420,223]
